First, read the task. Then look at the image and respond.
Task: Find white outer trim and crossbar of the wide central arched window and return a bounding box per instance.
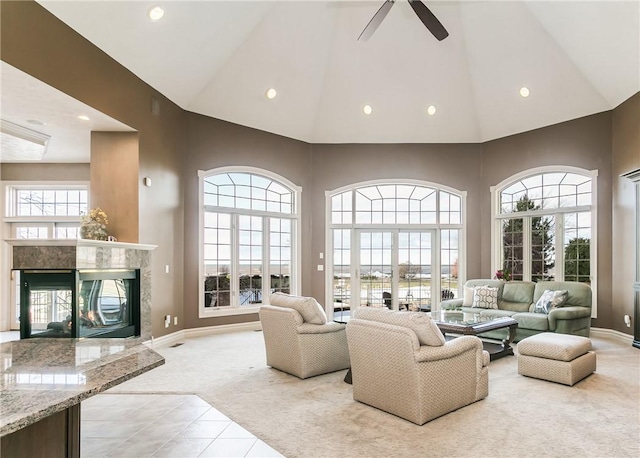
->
[324,179,467,316]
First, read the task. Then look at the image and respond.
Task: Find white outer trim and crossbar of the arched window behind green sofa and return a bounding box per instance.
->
[490,165,598,318]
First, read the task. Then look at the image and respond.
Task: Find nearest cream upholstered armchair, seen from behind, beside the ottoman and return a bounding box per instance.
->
[347,307,489,425]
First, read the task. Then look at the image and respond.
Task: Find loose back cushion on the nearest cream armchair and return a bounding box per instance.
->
[353,307,446,347]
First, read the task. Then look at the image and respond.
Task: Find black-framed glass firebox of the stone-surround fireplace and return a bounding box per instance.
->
[19,269,140,339]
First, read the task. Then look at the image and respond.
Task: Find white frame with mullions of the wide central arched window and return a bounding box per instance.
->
[324,179,467,316]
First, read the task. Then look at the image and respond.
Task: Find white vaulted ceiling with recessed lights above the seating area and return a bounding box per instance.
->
[3,0,640,162]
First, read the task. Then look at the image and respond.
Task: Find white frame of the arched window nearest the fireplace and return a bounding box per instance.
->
[198,166,302,318]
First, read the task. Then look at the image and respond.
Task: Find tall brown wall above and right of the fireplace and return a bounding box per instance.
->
[0,1,184,337]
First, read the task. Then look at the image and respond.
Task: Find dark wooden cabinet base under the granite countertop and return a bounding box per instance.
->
[0,404,80,458]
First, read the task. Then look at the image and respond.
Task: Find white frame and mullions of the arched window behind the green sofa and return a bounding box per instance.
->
[490,165,598,318]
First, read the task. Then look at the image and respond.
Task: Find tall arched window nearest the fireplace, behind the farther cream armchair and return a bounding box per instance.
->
[200,168,300,316]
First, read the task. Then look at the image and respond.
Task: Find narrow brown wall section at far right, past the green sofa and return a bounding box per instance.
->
[608,94,640,334]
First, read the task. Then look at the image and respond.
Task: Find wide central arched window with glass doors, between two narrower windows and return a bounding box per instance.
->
[327,182,466,311]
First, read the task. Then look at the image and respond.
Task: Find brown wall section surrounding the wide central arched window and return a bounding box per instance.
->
[305,144,482,300]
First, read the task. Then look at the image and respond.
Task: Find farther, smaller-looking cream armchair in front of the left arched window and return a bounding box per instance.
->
[260,293,349,379]
